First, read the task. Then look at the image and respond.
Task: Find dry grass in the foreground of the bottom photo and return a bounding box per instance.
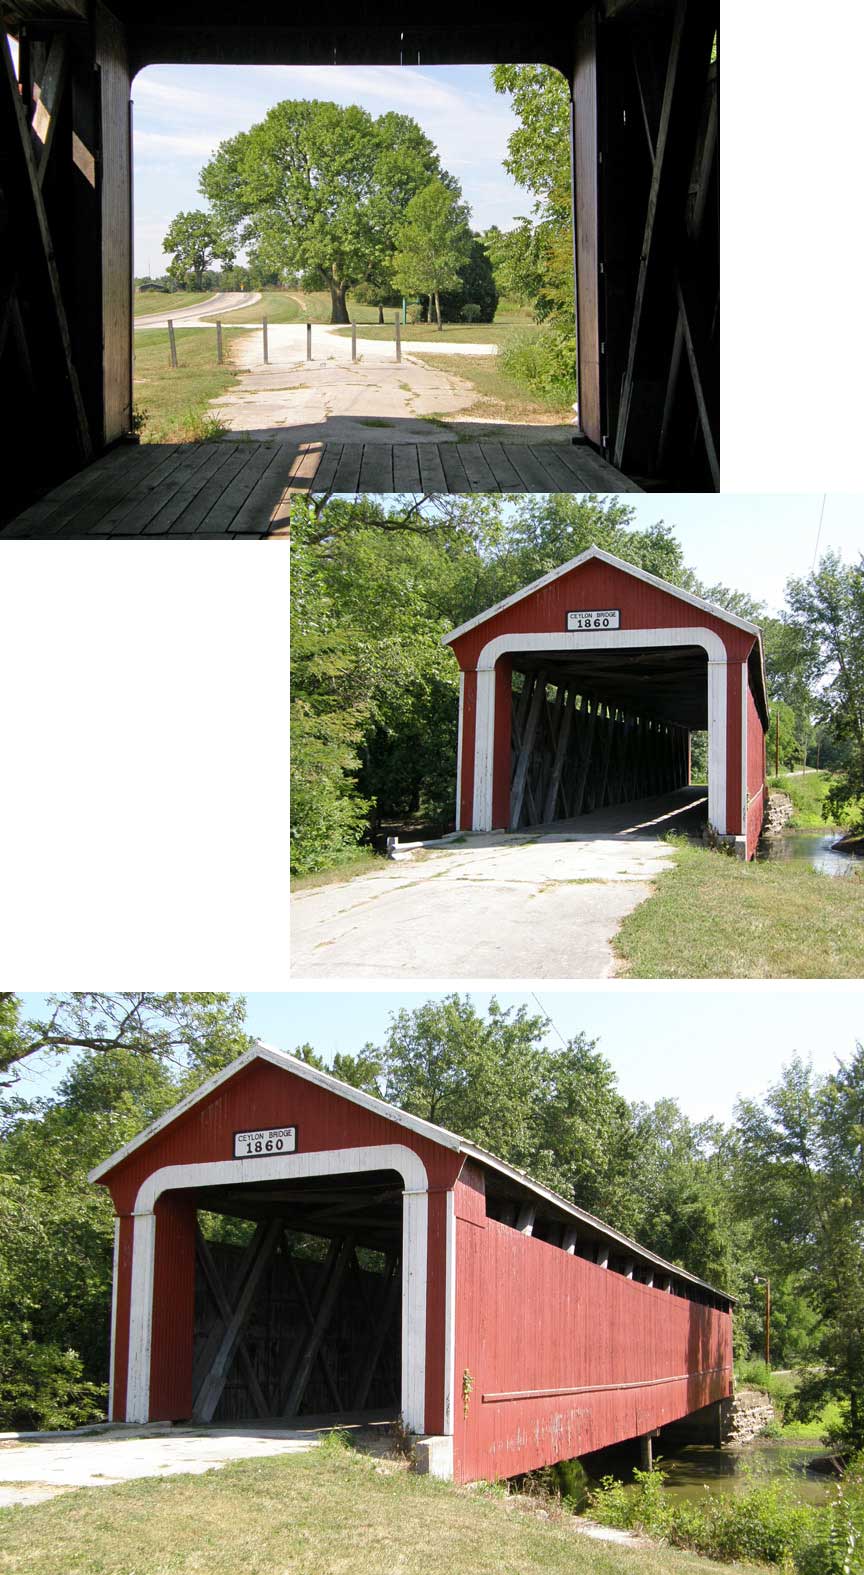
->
[0,1447,768,1575]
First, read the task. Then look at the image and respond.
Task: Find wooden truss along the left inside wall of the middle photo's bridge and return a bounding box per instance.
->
[510,669,689,832]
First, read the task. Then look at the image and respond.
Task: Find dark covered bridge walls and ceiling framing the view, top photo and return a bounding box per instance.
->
[0,0,719,529]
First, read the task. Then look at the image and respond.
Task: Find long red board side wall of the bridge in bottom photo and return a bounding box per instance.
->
[455,1186,732,1482]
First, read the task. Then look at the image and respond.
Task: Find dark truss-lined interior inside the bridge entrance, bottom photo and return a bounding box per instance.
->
[192,1172,403,1425]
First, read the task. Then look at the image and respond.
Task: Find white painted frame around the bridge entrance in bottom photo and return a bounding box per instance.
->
[124,1143,434,1433]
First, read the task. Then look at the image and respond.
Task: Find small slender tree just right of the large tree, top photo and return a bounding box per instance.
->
[393,181,471,328]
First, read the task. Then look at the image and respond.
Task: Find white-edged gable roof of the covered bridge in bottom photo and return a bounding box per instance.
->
[88,1040,735,1304]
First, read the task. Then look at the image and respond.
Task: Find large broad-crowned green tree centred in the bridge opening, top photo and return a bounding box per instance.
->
[200,99,456,323]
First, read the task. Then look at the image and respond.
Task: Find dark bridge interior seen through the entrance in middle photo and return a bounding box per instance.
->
[510,646,708,832]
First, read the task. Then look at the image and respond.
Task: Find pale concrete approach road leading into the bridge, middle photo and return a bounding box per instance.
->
[291,789,707,980]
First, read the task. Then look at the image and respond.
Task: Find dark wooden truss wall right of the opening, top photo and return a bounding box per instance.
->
[574,0,719,488]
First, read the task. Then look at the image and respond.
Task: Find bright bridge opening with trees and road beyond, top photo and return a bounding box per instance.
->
[132,59,576,450]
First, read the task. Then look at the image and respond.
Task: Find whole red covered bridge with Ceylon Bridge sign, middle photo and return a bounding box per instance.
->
[445,547,768,858]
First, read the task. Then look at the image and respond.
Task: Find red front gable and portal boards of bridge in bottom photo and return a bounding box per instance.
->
[97,1060,461,1433]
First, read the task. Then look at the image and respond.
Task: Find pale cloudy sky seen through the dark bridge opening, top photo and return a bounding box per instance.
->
[132,66,519,274]
